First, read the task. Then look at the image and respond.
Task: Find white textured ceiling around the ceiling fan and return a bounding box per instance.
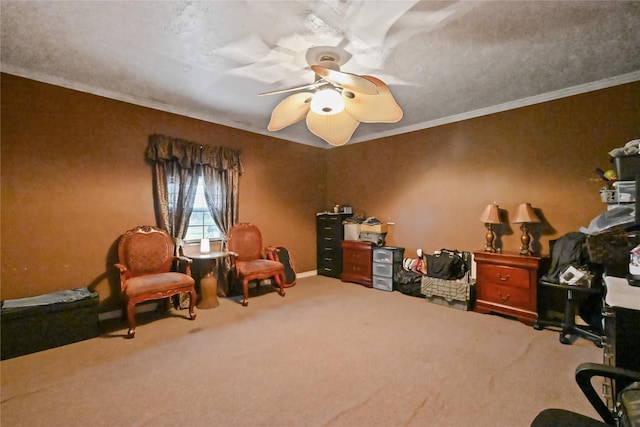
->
[0,0,640,147]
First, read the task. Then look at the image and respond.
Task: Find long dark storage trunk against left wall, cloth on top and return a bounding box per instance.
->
[0,288,98,360]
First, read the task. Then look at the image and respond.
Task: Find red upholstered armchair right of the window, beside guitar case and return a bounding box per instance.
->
[227,223,285,307]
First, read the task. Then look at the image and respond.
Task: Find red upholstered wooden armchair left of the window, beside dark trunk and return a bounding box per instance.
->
[115,225,196,338]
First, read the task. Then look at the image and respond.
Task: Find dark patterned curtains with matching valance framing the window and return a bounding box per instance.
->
[146,134,243,258]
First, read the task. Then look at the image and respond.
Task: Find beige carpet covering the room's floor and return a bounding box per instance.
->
[0,276,602,427]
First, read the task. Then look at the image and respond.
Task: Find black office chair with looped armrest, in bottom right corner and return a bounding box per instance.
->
[531,363,640,427]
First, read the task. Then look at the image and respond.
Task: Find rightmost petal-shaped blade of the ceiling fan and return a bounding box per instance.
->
[342,76,404,123]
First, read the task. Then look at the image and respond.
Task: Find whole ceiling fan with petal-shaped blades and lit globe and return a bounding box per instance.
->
[259,46,403,146]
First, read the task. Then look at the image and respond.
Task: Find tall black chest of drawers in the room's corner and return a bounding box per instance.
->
[316,213,350,279]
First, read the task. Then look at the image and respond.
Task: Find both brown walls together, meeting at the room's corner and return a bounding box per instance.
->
[1,74,640,310]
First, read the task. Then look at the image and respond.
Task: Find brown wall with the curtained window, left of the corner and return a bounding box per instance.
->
[1,74,326,309]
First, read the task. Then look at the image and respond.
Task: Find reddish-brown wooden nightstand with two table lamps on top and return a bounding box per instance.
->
[473,252,540,326]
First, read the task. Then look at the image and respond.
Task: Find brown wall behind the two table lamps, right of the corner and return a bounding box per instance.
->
[327,82,640,257]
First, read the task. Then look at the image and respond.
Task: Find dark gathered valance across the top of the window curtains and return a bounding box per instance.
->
[145,134,244,175]
